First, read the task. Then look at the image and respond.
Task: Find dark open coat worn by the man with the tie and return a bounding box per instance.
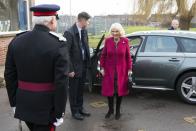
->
[63,24,90,77]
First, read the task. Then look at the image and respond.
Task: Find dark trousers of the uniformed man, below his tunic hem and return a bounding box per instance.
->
[25,122,55,131]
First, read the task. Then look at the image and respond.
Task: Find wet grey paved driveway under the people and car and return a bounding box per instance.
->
[0,89,196,131]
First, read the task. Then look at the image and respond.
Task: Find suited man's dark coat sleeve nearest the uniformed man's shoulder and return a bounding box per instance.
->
[63,31,74,72]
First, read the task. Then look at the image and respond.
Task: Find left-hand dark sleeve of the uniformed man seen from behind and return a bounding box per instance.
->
[4,40,18,107]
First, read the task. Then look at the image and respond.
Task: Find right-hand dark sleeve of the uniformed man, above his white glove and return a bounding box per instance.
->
[54,43,69,118]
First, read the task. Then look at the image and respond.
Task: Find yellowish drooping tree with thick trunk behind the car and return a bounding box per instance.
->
[137,0,196,29]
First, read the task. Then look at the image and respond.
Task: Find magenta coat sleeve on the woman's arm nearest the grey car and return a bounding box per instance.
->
[126,38,132,70]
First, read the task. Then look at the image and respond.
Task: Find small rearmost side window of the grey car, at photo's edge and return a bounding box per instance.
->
[180,38,196,53]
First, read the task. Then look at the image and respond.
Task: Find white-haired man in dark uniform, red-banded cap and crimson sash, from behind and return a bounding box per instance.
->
[4,5,69,131]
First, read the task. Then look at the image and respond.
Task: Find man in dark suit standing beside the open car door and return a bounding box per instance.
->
[64,12,90,120]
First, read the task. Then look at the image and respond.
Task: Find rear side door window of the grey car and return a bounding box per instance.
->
[144,36,178,52]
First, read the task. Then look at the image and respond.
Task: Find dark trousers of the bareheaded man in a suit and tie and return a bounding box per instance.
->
[69,67,86,114]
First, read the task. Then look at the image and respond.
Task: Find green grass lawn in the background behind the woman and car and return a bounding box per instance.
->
[89,26,196,48]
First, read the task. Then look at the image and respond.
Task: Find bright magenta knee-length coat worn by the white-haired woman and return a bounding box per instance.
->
[100,37,132,96]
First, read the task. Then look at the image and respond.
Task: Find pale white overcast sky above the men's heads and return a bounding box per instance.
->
[35,0,135,16]
